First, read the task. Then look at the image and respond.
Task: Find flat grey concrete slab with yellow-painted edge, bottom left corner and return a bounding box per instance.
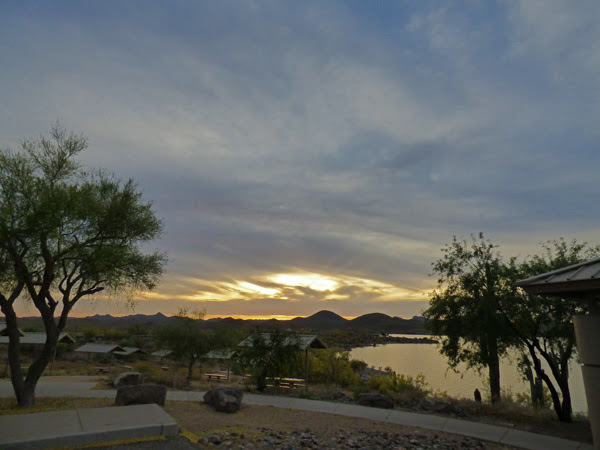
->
[0,404,179,450]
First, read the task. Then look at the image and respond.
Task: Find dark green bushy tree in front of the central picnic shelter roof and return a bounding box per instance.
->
[239,329,302,391]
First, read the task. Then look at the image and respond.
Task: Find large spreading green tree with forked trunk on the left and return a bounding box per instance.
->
[0,124,166,406]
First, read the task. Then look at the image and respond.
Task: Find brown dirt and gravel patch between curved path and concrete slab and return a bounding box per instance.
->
[165,402,513,450]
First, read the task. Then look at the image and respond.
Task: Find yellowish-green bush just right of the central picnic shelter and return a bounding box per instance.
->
[309,348,366,387]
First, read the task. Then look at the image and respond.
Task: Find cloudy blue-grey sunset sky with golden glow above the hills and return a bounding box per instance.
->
[0,0,600,318]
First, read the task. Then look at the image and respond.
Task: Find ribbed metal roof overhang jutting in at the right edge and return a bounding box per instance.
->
[517,258,600,297]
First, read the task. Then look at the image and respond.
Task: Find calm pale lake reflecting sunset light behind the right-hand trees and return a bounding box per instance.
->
[350,334,587,413]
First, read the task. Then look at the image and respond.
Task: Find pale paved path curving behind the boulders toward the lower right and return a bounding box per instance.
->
[0,377,593,450]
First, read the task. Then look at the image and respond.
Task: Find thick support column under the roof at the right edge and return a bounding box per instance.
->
[573,314,600,449]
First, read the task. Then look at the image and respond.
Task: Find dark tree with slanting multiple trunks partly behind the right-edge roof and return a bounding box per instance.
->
[502,238,600,422]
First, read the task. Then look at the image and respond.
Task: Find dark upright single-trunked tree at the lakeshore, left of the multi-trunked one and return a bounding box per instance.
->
[424,233,513,402]
